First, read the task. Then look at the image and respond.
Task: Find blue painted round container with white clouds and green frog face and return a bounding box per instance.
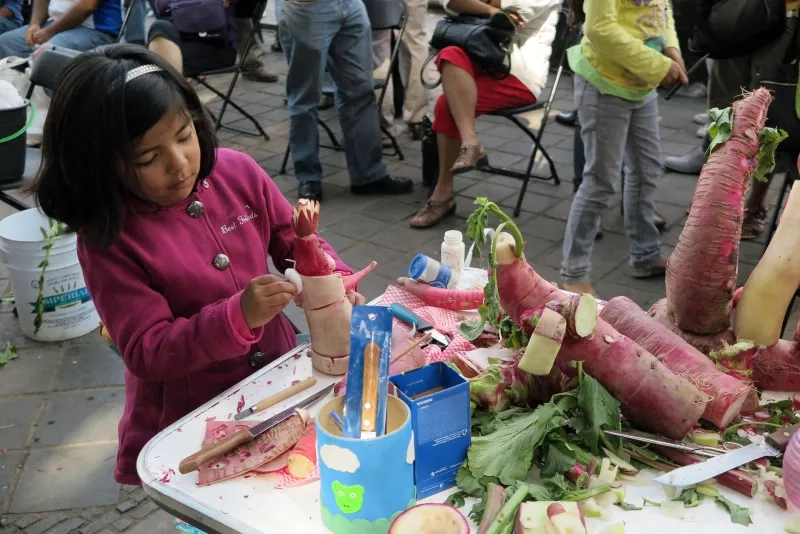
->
[315,395,416,534]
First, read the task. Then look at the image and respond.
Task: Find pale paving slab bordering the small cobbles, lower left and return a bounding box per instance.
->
[9,444,119,513]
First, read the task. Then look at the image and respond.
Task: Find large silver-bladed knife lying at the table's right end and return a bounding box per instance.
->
[653,423,800,487]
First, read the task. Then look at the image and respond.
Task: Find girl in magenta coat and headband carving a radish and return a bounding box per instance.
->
[33,45,363,490]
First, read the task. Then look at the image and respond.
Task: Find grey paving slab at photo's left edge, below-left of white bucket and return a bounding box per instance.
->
[0,348,62,398]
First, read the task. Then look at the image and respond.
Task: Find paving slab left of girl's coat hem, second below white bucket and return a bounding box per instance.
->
[36,388,125,446]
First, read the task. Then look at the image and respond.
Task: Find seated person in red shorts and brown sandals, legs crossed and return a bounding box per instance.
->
[411,0,561,228]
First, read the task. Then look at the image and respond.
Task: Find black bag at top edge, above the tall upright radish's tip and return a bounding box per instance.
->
[689,0,786,59]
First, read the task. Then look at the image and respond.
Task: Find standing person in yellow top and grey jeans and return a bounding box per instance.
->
[561,0,687,293]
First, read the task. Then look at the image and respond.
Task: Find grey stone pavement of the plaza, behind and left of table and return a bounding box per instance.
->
[0,18,776,534]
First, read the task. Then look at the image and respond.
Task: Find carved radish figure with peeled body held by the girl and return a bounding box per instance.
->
[292,199,376,375]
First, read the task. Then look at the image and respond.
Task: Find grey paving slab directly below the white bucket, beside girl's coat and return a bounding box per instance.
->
[56,341,125,390]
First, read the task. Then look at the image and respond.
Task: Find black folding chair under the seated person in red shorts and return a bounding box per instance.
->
[476,29,573,217]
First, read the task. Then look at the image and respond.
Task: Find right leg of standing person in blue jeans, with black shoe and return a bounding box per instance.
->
[328,0,413,194]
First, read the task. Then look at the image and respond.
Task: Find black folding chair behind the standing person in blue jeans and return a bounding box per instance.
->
[278,0,408,174]
